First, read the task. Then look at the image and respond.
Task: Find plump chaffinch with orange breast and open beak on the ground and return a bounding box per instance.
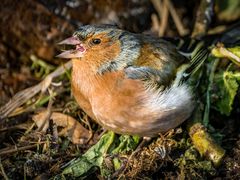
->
[58,25,206,137]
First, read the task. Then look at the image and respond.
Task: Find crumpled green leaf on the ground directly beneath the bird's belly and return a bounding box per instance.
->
[62,132,140,177]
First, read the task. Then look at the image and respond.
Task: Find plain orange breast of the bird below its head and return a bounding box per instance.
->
[72,60,148,134]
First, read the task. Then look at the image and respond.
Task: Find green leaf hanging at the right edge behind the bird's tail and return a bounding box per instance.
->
[215,71,240,115]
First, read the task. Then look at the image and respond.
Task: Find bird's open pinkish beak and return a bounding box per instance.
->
[56,37,86,59]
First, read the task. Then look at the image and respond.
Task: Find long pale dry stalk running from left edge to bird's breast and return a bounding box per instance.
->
[0,61,72,121]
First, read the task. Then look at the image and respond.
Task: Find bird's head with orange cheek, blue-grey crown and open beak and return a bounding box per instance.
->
[57,25,139,73]
